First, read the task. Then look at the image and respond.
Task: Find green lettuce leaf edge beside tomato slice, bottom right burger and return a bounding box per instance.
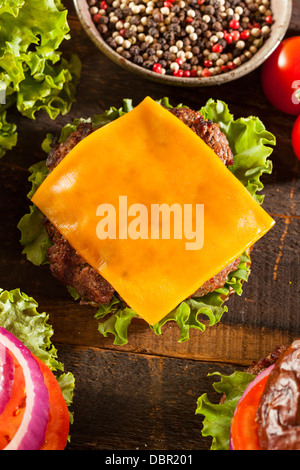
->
[196,371,255,450]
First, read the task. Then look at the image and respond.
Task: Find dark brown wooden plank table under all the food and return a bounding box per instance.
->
[0,0,300,450]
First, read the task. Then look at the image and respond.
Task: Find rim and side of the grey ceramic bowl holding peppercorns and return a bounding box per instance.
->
[74,0,292,87]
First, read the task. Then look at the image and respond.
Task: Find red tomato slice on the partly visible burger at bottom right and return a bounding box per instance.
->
[231,374,269,450]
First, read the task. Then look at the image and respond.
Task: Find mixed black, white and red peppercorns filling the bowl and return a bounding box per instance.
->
[87,0,273,77]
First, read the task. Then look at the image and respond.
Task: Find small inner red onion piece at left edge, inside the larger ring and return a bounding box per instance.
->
[0,344,15,414]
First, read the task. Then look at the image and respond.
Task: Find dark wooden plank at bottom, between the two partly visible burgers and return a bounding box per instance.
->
[61,346,241,450]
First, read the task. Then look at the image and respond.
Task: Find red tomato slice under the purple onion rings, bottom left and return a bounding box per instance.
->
[0,356,70,450]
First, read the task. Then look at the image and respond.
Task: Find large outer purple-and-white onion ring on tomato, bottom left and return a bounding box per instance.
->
[0,327,49,450]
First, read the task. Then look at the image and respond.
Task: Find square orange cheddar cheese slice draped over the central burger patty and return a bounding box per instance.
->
[32,97,274,325]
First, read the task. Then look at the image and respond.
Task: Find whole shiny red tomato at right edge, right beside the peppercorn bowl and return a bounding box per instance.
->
[262,36,300,116]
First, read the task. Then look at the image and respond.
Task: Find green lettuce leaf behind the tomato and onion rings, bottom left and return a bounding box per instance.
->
[0,288,75,416]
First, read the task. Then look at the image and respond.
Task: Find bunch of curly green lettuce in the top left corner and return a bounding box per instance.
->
[0,0,81,158]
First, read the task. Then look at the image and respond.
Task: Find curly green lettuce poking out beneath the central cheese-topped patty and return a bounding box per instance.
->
[18,98,275,345]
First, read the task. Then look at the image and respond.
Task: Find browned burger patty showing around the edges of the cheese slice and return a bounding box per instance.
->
[44,108,239,305]
